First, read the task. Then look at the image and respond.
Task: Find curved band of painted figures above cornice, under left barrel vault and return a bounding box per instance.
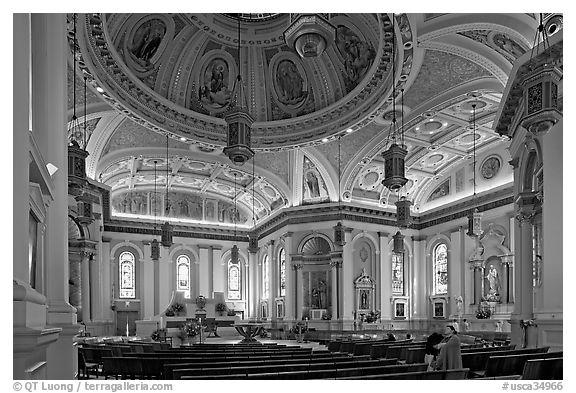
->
[112,191,248,224]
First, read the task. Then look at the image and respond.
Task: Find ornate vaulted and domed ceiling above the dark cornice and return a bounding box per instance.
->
[69,14,556,225]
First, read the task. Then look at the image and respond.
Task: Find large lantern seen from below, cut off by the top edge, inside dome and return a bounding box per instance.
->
[284,14,336,58]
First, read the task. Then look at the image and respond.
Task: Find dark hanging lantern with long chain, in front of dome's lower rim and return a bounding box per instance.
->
[222,14,254,166]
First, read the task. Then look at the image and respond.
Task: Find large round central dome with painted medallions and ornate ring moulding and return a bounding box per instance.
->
[76,14,400,150]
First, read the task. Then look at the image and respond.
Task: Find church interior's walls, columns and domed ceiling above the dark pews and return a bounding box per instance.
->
[13,13,563,380]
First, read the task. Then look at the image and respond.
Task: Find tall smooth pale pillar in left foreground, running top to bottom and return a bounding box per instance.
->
[32,14,79,379]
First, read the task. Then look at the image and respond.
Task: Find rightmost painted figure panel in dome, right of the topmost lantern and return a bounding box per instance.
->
[336,26,376,90]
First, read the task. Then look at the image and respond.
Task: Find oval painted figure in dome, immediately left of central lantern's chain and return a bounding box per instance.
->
[198,58,232,109]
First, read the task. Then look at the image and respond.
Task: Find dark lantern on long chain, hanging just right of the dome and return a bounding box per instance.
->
[382,15,408,191]
